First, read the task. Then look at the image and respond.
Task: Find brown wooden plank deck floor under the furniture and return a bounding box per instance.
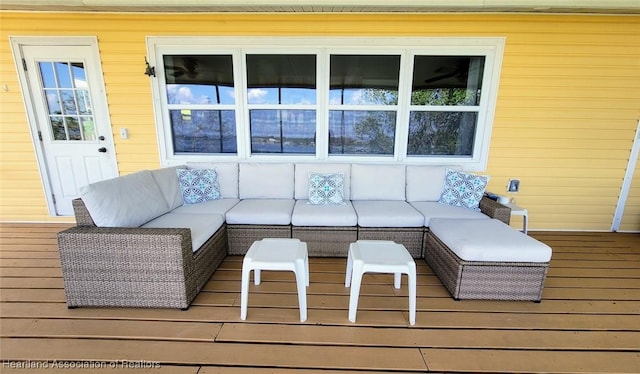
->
[0,223,640,374]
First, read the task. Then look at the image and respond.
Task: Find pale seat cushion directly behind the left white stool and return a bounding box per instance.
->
[226,199,296,225]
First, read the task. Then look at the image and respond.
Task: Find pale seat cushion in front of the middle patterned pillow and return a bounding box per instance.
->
[291,200,358,226]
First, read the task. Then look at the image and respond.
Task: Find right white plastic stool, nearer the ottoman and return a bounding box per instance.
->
[344,240,416,325]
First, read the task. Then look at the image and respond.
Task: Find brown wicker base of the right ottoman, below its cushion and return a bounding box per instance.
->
[425,232,549,301]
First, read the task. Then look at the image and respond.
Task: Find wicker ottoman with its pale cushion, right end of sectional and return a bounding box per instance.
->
[425,218,551,302]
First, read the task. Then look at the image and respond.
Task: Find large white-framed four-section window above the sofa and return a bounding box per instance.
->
[149,37,504,170]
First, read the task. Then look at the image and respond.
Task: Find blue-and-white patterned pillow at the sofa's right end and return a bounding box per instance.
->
[438,169,489,210]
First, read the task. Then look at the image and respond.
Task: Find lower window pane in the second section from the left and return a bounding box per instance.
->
[249,109,316,154]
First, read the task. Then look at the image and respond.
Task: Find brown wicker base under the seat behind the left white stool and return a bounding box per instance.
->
[227,225,291,255]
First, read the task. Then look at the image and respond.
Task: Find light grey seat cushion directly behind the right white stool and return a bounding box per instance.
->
[352,200,424,227]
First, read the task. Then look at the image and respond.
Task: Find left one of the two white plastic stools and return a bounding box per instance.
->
[240,238,309,322]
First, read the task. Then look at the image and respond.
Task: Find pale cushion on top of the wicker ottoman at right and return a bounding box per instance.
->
[429,218,551,262]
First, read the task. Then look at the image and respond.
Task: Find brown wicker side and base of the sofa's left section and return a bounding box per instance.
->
[58,226,227,309]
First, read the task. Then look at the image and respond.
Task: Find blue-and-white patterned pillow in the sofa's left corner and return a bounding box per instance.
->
[176,169,220,204]
